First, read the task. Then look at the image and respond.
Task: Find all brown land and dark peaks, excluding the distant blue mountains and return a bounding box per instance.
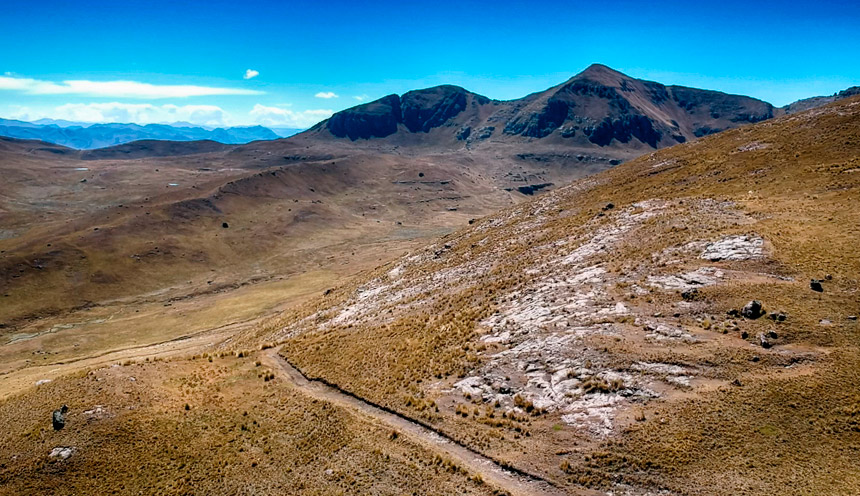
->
[0,65,860,496]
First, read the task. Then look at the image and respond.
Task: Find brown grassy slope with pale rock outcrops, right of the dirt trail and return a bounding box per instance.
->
[242,97,860,495]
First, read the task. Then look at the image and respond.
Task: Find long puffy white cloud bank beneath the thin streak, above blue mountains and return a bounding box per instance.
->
[11,102,231,126]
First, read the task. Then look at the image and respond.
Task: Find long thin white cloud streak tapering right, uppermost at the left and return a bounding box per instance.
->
[0,76,263,98]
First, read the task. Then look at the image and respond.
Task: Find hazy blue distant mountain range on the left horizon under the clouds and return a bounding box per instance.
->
[0,119,302,150]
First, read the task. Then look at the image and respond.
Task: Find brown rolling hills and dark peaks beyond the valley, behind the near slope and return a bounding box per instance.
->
[0,65,784,328]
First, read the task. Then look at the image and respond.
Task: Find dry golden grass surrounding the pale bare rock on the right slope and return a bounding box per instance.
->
[252,98,860,494]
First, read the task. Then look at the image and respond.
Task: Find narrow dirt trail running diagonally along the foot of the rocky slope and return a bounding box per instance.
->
[262,349,584,496]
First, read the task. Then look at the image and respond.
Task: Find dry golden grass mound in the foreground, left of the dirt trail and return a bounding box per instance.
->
[0,356,491,495]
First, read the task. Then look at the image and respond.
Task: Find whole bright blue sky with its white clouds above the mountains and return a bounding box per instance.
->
[0,0,860,127]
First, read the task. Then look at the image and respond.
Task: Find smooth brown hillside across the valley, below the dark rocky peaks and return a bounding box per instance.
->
[0,144,512,324]
